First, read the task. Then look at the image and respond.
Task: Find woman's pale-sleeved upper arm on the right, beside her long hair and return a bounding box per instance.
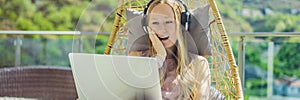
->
[193,56,211,100]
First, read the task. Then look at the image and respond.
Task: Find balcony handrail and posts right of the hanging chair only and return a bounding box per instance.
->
[228,32,300,99]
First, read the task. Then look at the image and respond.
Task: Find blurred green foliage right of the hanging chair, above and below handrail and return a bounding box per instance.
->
[217,0,300,96]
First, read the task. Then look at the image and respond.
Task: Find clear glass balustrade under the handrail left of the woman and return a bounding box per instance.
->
[0,34,108,67]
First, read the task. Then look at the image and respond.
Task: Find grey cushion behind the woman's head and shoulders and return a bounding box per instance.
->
[125,5,212,56]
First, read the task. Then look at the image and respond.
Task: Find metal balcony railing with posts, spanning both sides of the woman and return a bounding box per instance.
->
[0,31,300,97]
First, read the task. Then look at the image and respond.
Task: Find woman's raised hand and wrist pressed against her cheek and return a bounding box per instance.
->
[147,27,167,66]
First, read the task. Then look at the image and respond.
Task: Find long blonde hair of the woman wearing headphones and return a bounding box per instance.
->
[148,0,200,100]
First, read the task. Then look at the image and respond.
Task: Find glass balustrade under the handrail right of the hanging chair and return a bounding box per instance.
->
[230,36,300,100]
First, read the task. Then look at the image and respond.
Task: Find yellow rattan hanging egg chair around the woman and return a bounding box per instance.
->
[104,0,244,100]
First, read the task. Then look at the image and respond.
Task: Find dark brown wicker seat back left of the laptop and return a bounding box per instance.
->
[0,66,77,100]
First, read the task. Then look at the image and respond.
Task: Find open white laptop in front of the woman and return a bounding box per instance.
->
[69,53,162,100]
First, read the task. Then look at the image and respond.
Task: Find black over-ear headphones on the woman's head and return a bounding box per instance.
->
[142,0,191,33]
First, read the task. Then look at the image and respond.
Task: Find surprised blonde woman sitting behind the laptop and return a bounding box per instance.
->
[129,0,211,100]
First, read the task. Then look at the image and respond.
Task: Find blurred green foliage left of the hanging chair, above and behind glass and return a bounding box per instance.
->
[0,0,113,67]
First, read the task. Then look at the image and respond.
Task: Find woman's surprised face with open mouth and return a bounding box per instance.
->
[148,4,177,48]
